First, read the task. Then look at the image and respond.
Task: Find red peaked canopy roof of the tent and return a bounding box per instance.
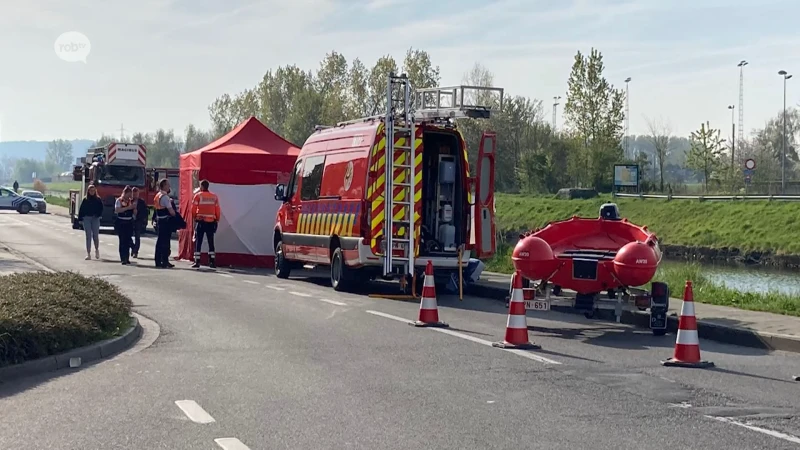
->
[180,117,300,186]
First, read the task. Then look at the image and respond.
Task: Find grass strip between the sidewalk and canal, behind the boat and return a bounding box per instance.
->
[486,243,800,317]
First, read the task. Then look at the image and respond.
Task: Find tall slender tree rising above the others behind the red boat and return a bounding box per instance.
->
[564,48,625,189]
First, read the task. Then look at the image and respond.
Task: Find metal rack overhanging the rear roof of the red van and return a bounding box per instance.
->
[414,85,504,119]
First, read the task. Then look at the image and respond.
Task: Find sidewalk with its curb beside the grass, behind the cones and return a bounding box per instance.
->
[474,272,800,353]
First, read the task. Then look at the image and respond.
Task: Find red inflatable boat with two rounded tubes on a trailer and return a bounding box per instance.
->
[512,203,661,297]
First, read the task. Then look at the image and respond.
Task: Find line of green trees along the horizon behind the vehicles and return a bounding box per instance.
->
[15,48,800,194]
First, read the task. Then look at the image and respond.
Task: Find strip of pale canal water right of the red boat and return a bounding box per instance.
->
[661,261,800,297]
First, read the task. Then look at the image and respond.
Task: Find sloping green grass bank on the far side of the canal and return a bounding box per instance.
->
[496,194,800,255]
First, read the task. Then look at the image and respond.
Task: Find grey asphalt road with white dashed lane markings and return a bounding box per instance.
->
[0,213,800,450]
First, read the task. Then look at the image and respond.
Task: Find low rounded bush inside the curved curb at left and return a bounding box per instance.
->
[0,272,131,367]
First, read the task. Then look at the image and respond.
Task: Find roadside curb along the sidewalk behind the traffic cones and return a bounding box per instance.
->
[471,282,800,353]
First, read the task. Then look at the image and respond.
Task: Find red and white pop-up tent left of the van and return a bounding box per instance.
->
[179,117,300,267]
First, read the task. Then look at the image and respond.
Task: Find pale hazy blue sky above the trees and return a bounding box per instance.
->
[0,0,800,141]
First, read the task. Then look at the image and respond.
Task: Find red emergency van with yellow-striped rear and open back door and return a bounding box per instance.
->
[273,75,503,291]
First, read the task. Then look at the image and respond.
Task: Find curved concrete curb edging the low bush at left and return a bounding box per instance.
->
[0,317,142,382]
